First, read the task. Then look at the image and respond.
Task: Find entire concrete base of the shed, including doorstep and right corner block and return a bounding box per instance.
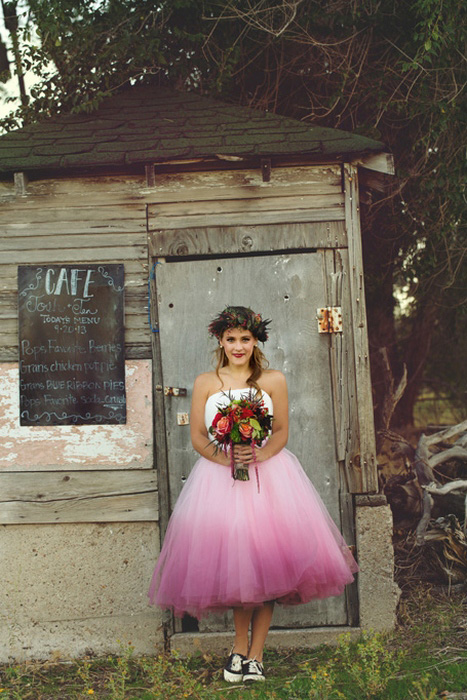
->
[0,501,400,663]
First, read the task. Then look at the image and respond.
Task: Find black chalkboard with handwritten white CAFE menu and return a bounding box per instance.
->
[18,264,126,425]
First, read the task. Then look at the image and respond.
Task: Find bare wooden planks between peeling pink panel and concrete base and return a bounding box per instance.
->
[0,469,158,525]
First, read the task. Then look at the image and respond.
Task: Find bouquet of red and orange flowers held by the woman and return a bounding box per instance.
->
[209,389,272,481]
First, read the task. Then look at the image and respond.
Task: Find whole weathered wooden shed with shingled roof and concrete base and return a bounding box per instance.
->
[0,88,397,661]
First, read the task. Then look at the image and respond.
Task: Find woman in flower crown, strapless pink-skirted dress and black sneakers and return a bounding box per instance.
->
[149,306,358,682]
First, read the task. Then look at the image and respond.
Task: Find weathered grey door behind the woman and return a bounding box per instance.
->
[153,234,356,631]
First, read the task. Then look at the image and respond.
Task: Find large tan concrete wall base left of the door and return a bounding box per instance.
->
[0,522,164,663]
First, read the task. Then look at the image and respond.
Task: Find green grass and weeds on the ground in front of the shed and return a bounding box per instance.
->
[0,587,467,700]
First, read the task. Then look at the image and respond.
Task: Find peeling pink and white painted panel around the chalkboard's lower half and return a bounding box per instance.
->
[0,360,153,471]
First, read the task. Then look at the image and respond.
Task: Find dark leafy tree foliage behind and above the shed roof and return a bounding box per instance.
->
[1,0,467,423]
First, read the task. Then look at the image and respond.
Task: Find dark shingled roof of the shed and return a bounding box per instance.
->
[0,87,384,174]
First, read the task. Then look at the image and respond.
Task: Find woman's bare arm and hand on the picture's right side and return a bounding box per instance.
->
[234,370,289,464]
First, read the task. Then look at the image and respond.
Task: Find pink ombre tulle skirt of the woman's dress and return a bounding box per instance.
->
[149,449,358,618]
